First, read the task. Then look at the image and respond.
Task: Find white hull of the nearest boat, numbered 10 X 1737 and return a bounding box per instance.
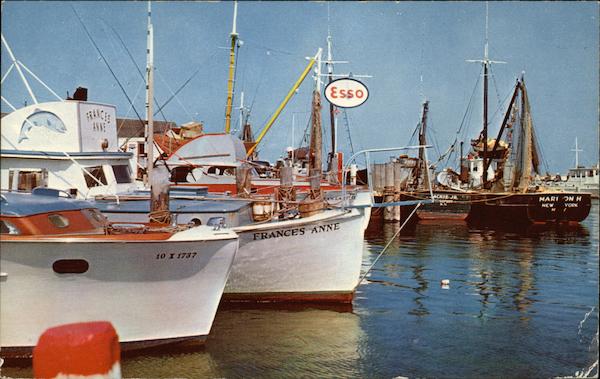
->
[0,227,238,349]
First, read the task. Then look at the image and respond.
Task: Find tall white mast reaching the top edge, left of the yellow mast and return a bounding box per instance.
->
[146,1,154,186]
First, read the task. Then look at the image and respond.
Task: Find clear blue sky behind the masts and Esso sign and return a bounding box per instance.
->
[2,1,599,172]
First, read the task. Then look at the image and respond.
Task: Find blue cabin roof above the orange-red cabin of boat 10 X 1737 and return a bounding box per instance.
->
[0,191,94,217]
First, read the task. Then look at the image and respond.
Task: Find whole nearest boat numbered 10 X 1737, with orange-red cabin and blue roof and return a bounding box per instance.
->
[0,188,238,357]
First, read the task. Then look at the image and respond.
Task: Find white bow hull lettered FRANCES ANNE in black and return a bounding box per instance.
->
[224,209,366,301]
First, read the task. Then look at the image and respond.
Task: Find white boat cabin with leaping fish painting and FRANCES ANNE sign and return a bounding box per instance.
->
[0,100,137,198]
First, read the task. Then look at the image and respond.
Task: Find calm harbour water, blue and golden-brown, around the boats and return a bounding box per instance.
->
[2,201,598,378]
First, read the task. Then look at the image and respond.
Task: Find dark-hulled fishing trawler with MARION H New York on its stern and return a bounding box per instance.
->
[469,77,591,224]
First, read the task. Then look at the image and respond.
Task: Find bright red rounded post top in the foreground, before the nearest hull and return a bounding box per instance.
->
[33,321,121,379]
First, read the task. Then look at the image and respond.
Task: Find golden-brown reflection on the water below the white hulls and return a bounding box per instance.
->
[122,306,363,378]
